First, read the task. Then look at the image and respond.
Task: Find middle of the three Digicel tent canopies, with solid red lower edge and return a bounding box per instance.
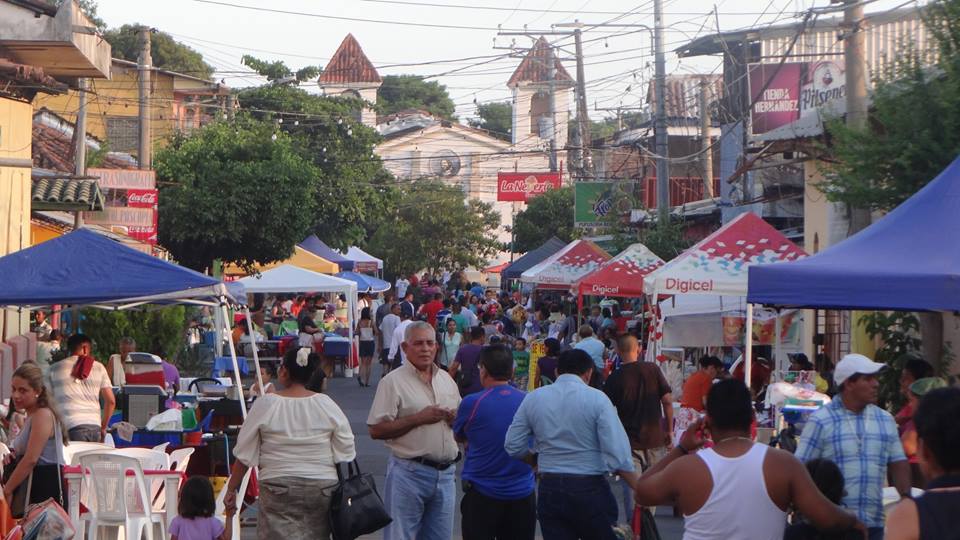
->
[576,243,664,310]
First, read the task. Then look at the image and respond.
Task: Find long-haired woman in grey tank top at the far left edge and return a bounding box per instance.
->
[3,362,66,516]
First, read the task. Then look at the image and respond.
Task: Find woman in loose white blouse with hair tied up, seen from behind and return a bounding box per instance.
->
[224,348,356,540]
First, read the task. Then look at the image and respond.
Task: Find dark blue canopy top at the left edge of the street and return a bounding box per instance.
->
[0,229,226,306]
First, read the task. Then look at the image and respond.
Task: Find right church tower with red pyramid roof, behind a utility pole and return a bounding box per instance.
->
[507,36,574,149]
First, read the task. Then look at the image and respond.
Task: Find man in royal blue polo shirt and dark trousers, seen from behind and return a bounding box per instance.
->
[453,345,537,540]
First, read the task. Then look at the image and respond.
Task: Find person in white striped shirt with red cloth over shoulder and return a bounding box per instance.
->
[49,334,117,442]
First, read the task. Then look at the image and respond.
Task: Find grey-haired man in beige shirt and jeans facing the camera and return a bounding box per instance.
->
[367,322,460,540]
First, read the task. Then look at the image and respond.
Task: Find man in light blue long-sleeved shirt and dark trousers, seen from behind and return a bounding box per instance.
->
[504,349,637,540]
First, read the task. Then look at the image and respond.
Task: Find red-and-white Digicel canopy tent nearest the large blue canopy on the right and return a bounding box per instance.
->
[643,212,807,381]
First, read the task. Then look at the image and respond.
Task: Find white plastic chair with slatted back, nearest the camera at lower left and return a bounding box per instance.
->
[80,452,166,540]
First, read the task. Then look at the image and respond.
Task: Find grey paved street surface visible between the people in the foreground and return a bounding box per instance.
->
[243,376,683,540]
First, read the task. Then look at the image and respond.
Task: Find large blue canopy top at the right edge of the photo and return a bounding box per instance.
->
[747,154,960,311]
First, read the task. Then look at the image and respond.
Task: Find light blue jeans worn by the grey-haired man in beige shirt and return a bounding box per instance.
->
[383,456,457,540]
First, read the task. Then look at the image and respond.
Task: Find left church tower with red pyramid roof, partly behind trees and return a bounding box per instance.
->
[319,34,383,128]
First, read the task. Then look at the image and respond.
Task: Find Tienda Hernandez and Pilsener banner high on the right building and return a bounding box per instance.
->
[748,60,846,135]
